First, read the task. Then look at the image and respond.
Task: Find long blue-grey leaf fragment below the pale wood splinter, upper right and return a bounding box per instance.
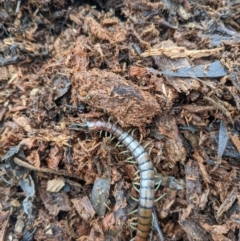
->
[162,60,228,78]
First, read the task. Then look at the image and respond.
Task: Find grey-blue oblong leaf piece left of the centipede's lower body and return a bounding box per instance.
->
[91,178,111,218]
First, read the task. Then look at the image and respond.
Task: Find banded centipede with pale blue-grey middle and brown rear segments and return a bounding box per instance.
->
[77,120,155,241]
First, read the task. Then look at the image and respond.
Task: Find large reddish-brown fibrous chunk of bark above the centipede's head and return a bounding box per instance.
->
[74,69,161,127]
